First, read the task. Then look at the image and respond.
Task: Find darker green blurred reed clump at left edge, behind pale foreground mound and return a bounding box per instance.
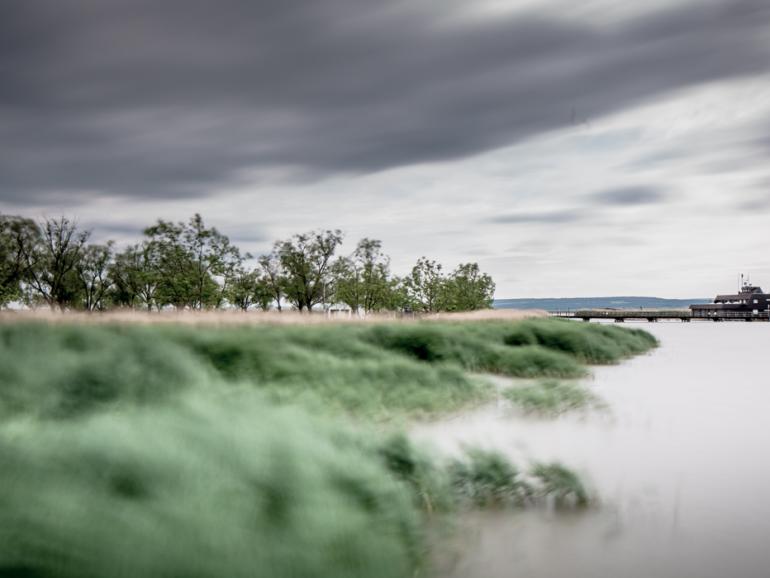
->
[0,323,212,418]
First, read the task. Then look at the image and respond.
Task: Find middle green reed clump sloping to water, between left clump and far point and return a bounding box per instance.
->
[163,325,491,418]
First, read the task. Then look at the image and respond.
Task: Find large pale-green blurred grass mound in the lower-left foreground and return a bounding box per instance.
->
[0,397,423,578]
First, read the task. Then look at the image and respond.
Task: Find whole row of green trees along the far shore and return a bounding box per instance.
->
[0,214,495,313]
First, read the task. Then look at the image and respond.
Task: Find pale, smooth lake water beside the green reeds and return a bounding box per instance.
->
[413,322,770,578]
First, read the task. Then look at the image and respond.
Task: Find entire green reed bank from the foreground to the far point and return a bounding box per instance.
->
[0,319,655,578]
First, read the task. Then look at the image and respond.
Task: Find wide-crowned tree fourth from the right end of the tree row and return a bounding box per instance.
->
[275,230,342,312]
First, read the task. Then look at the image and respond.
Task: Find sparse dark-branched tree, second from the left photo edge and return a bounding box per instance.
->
[23,217,91,310]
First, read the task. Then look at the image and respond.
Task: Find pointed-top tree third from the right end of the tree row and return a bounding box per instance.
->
[333,239,393,313]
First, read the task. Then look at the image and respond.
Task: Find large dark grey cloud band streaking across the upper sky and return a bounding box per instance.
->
[0,0,770,204]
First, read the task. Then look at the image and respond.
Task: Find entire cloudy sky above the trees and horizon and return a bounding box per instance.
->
[0,0,770,298]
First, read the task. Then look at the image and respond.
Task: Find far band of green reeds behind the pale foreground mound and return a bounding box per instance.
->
[0,319,655,418]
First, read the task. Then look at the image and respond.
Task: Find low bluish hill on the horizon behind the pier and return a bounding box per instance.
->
[492,297,712,311]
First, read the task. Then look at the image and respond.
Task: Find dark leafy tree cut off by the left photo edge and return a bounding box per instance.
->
[0,215,41,307]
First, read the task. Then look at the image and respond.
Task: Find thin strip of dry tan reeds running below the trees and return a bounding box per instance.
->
[0,309,547,326]
